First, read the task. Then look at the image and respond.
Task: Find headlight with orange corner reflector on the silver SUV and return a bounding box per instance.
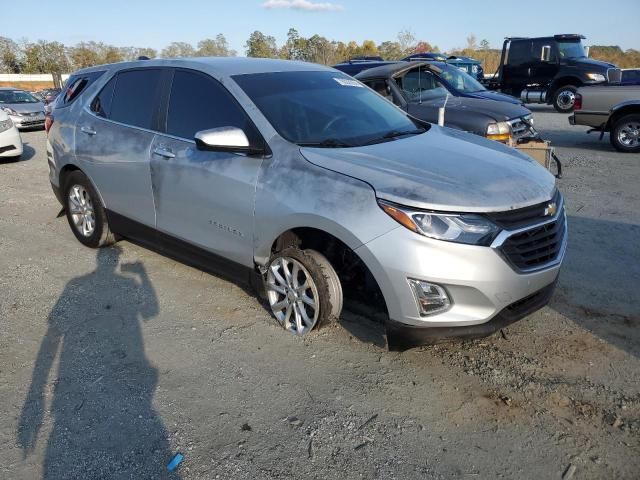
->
[378,200,500,245]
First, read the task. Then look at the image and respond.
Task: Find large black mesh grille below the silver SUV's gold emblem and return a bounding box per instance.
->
[501,208,567,271]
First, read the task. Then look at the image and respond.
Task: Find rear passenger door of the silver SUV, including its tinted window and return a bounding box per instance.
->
[75,68,163,227]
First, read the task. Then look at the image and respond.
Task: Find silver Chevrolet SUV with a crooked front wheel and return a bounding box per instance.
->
[48,58,566,346]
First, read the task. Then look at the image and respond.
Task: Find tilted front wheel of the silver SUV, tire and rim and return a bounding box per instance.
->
[265,247,343,335]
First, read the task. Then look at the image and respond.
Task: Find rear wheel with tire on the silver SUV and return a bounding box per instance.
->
[62,170,115,248]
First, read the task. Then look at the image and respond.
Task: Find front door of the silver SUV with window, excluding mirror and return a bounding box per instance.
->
[151,69,262,268]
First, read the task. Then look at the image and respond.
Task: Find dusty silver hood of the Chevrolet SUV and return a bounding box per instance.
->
[300,125,555,212]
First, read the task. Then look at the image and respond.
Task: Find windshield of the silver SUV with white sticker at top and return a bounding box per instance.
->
[233,71,424,148]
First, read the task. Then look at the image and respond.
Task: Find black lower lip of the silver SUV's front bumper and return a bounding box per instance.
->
[385,281,557,351]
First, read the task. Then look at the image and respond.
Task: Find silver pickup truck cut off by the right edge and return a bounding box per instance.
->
[569,85,640,153]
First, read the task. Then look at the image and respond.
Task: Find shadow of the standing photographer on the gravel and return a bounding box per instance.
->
[17,247,178,480]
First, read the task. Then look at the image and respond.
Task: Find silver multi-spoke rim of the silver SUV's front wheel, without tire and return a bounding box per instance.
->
[267,257,320,335]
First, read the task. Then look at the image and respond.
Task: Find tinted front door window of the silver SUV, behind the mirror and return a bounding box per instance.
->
[167,70,253,140]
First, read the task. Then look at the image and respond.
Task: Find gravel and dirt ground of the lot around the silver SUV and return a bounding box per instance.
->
[0,107,640,479]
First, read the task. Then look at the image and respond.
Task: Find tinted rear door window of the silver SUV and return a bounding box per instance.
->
[108,69,161,129]
